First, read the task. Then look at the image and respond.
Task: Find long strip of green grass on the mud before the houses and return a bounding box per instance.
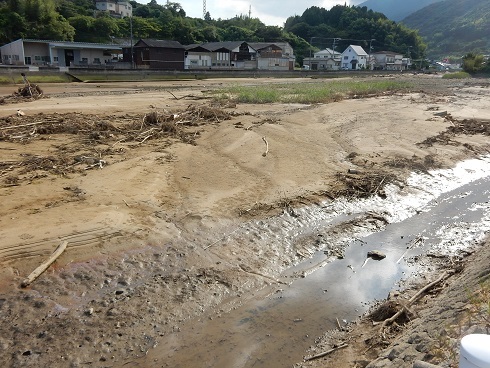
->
[213,80,411,104]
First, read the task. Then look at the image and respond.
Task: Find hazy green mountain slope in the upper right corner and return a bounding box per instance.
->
[403,0,490,57]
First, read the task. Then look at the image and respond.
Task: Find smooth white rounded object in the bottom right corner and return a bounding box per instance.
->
[459,334,490,368]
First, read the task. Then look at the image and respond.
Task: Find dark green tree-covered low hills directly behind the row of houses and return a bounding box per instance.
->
[0,0,425,63]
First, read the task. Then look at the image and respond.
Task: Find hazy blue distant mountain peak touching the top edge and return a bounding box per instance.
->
[358,0,445,22]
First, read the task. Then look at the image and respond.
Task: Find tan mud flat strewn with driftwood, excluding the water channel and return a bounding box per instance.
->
[0,76,490,367]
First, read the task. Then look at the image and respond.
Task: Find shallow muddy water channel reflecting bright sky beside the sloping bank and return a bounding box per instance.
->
[141,157,490,368]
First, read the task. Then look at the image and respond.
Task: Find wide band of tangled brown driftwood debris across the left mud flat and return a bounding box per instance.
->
[0,105,237,186]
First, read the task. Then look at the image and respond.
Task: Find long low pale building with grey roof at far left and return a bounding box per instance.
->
[0,39,122,67]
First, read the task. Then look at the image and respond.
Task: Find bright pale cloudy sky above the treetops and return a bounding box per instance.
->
[155,0,365,27]
